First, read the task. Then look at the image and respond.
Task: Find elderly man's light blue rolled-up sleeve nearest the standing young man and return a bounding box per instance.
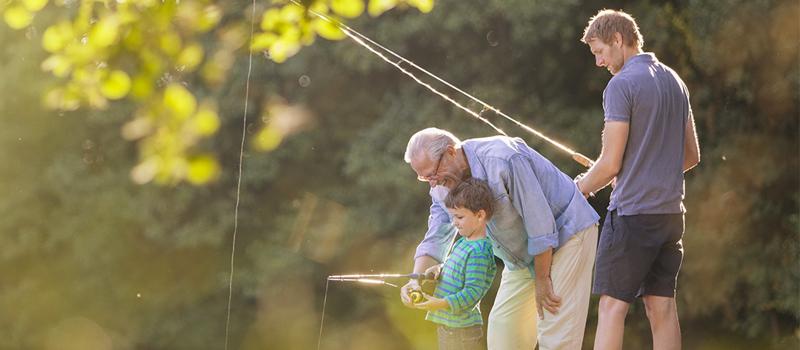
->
[508,155,558,256]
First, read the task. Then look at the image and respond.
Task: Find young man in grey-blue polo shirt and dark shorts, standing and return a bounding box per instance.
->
[577,10,700,349]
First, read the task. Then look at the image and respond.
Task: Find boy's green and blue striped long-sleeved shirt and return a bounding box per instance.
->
[425,237,497,328]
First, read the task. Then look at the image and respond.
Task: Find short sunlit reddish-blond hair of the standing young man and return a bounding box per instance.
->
[581,9,644,49]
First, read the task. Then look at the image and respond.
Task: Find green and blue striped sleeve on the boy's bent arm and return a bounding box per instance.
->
[444,249,497,312]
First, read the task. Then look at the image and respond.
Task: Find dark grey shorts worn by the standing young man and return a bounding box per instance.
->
[592,210,684,303]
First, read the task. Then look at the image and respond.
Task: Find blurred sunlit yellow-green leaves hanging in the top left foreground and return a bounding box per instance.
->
[2,0,433,185]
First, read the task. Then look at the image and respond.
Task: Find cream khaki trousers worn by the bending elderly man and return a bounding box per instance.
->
[486,225,597,350]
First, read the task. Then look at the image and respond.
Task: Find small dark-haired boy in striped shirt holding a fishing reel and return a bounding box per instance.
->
[415,178,496,350]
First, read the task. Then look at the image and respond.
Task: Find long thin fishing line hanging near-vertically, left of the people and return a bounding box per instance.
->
[225,0,256,350]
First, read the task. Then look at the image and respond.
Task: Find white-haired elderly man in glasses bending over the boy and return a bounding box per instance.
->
[400,128,599,350]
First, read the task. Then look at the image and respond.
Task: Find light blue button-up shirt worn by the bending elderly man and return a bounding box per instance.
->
[415,136,600,270]
